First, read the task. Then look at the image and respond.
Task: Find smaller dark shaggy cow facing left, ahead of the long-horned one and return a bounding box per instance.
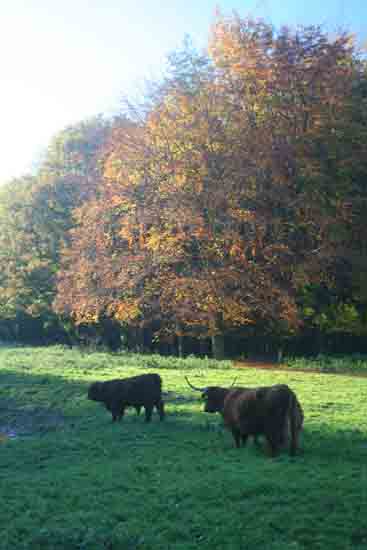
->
[88,374,164,422]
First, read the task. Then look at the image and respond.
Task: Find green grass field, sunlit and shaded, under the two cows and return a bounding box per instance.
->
[0,347,367,550]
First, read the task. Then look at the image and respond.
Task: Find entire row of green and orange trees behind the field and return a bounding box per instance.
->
[0,15,367,357]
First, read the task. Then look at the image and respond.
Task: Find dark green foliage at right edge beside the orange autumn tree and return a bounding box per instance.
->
[299,60,367,350]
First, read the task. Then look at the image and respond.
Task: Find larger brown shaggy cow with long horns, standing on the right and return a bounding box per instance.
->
[187,380,303,456]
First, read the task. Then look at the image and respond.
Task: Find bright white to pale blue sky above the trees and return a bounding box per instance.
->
[0,0,367,184]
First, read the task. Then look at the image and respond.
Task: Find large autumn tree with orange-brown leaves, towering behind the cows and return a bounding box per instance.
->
[56,17,365,357]
